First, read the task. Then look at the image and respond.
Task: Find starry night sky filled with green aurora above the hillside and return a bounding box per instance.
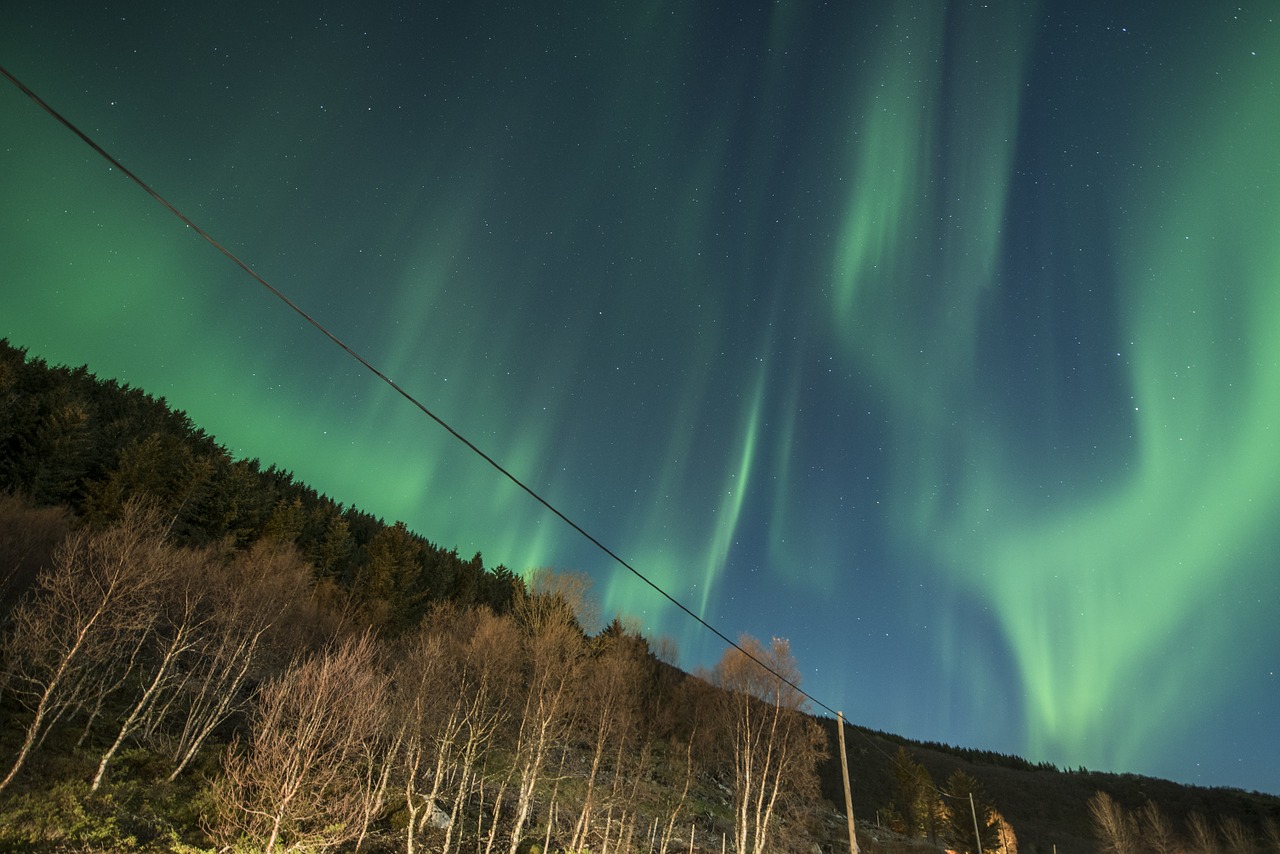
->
[0,0,1280,793]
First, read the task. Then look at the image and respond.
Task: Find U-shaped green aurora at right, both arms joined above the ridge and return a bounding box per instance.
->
[833,6,1280,768]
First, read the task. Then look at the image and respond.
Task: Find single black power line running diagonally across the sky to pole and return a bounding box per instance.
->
[0,65,837,714]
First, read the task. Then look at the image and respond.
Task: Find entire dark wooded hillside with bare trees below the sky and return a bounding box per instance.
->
[0,342,1280,854]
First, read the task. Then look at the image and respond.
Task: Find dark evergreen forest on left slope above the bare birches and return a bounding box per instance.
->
[0,339,521,626]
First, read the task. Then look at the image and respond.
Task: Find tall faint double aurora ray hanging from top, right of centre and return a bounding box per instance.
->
[832,3,1034,530]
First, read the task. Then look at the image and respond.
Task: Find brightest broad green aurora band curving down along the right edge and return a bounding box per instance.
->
[973,38,1280,767]
